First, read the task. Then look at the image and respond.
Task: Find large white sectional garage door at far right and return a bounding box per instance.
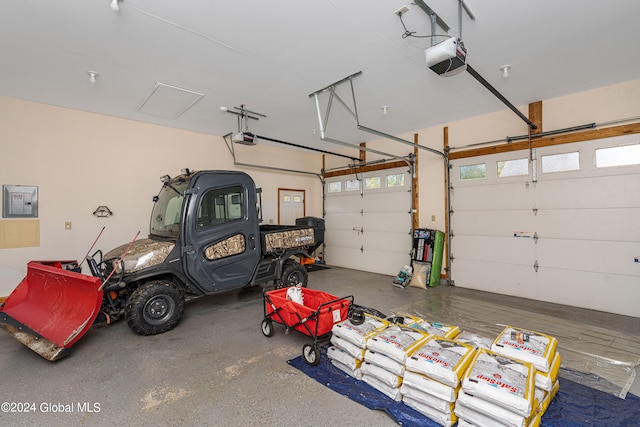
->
[451,135,640,317]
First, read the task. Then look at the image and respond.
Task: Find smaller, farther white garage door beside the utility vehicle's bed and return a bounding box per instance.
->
[325,168,411,275]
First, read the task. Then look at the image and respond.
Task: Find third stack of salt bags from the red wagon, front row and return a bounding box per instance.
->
[400,337,476,426]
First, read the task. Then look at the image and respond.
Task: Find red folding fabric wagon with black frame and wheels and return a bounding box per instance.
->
[262,288,353,366]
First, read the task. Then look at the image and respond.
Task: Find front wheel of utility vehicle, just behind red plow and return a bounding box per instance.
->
[124,280,184,335]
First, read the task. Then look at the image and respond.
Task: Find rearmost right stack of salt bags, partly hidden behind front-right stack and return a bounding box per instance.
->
[491,326,562,422]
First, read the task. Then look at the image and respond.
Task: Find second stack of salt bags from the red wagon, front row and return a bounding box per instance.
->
[360,324,430,401]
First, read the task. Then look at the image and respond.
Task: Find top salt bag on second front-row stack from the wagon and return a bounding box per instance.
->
[367,325,429,363]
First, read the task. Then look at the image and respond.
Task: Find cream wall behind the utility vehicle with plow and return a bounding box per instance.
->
[0,97,322,296]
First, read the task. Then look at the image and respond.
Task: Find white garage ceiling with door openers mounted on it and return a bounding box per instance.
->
[0,0,640,155]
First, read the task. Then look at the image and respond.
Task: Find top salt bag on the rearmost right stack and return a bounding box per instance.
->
[491,326,558,372]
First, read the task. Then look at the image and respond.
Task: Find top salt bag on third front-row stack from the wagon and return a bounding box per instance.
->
[405,337,476,387]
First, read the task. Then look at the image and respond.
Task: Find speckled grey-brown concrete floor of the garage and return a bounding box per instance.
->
[0,268,640,426]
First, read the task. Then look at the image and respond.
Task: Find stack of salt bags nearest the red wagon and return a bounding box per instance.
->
[327,313,389,379]
